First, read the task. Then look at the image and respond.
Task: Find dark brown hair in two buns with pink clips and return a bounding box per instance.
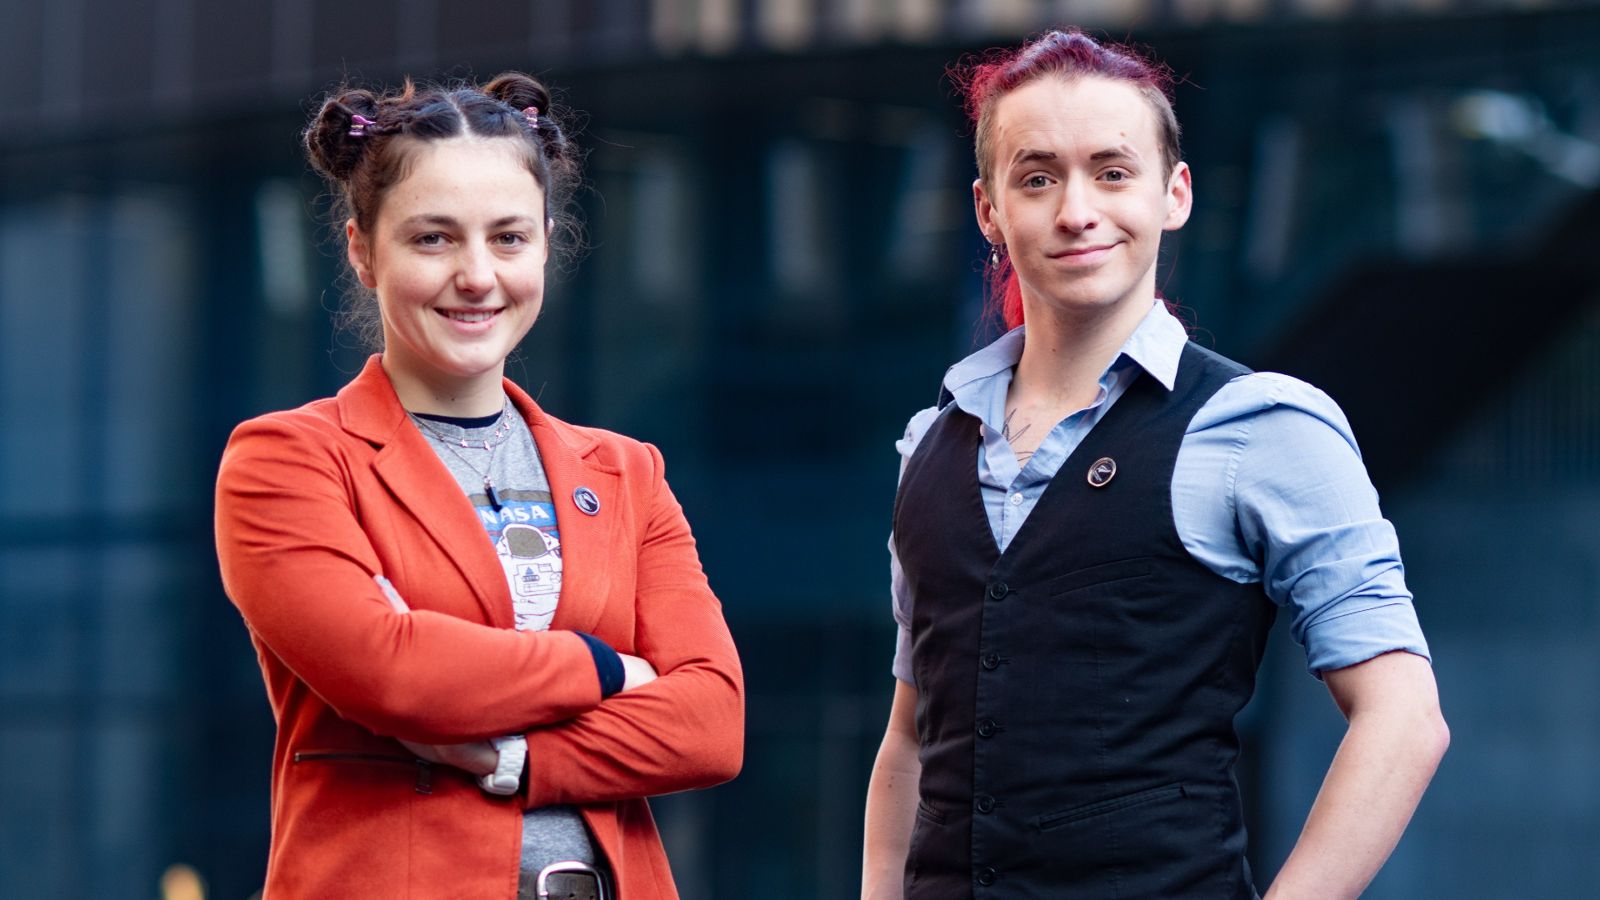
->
[304,72,582,348]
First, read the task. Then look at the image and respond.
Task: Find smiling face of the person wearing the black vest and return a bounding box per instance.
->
[973,75,1190,322]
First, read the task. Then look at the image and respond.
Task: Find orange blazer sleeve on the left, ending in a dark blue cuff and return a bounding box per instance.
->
[216,416,600,743]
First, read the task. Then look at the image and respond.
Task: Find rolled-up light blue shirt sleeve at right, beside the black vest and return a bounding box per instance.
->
[1173,373,1429,677]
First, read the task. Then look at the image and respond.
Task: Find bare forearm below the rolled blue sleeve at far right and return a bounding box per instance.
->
[1267,653,1450,900]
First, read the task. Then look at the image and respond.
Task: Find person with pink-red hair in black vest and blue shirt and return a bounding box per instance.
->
[862,30,1450,900]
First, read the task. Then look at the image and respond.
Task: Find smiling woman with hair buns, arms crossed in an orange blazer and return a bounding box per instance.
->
[216,74,744,900]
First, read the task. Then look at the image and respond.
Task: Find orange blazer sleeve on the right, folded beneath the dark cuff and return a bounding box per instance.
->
[523,445,744,797]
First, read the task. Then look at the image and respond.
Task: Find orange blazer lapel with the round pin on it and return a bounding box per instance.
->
[506,381,622,631]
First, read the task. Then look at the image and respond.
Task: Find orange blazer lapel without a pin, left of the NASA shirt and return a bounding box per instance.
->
[339,356,512,628]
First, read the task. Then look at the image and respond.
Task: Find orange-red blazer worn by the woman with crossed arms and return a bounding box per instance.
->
[216,357,744,900]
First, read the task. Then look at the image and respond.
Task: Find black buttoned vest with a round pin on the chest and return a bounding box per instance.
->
[894,344,1275,900]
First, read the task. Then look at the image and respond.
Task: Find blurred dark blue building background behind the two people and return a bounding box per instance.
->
[0,0,1600,900]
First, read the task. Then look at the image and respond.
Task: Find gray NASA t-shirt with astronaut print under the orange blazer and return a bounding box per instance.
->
[413,404,598,898]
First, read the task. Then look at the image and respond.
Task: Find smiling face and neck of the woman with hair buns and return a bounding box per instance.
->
[346,136,549,415]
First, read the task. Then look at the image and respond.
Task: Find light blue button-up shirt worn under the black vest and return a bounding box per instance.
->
[890,301,1429,682]
